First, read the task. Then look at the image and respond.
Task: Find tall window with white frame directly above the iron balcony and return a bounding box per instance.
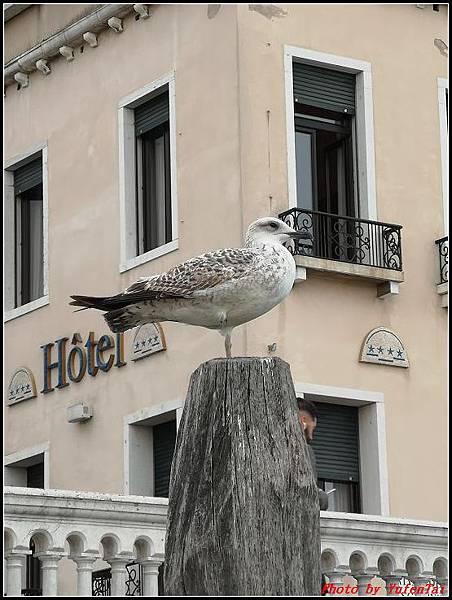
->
[284,45,377,221]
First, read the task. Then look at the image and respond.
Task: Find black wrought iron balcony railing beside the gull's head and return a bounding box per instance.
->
[279,208,402,271]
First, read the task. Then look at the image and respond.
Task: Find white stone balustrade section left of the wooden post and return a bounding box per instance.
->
[4,487,168,596]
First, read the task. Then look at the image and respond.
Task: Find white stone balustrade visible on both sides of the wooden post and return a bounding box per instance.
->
[4,487,447,596]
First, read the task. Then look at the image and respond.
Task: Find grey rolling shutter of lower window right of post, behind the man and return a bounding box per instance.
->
[312,402,359,482]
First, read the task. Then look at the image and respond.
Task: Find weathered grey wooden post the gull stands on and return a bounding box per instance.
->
[165,358,321,596]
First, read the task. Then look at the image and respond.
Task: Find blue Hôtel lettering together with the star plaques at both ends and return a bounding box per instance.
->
[7,323,166,405]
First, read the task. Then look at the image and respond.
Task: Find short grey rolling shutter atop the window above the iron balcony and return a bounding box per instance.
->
[293,62,356,114]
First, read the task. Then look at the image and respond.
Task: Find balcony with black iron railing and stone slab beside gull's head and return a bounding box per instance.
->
[279,208,403,298]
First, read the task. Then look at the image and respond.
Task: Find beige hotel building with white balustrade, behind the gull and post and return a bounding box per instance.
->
[4,4,448,595]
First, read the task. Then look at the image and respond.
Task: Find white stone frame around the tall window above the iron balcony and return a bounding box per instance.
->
[284,45,377,221]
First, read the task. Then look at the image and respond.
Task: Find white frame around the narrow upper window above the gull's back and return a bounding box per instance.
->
[118,72,179,273]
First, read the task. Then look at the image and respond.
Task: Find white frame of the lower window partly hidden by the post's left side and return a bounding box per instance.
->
[123,400,183,496]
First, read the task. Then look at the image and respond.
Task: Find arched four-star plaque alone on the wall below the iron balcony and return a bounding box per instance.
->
[360,327,410,367]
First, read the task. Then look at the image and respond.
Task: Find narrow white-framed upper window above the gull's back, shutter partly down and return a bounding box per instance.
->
[119,75,178,272]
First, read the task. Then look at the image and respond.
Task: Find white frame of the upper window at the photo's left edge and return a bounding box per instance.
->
[3,142,50,322]
